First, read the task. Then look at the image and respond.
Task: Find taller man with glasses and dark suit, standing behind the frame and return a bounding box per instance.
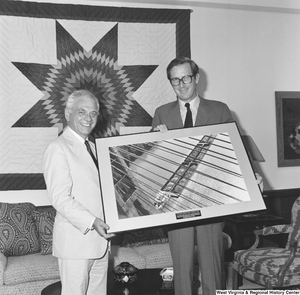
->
[152,57,233,295]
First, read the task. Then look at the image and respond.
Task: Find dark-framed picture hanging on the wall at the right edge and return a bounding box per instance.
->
[275,91,300,167]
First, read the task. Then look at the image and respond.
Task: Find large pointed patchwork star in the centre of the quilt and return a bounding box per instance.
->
[12,22,157,137]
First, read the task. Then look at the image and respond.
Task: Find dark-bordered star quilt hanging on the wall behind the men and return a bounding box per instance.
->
[0,0,190,191]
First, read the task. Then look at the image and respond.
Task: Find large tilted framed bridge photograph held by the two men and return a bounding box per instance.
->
[96,123,265,233]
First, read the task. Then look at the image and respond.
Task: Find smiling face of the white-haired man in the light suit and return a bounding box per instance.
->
[65,96,99,139]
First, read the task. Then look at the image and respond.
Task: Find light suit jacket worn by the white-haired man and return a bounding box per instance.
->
[43,127,107,259]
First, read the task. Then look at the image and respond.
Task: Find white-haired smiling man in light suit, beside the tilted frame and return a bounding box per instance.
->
[43,90,113,295]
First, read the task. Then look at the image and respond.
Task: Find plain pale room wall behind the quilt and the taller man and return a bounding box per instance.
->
[0,0,300,205]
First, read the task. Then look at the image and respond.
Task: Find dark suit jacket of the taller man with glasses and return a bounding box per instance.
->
[152,97,233,129]
